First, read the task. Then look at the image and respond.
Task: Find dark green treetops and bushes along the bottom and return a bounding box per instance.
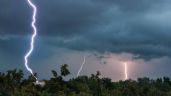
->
[0,64,171,96]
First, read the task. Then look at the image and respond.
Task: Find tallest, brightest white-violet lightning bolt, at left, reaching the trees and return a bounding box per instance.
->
[24,0,37,80]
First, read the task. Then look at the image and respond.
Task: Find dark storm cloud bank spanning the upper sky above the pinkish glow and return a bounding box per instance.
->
[0,0,171,58]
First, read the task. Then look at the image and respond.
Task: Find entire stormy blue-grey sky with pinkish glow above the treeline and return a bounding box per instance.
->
[0,0,171,80]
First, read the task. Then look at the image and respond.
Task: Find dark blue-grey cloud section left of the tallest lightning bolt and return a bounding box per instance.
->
[0,0,31,35]
